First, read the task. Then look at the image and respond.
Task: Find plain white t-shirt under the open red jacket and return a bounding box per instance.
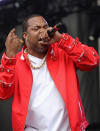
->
[25,55,71,131]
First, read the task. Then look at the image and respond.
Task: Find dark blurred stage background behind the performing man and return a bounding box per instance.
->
[0,0,100,131]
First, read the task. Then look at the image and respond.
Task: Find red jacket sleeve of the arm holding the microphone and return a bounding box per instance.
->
[58,33,99,71]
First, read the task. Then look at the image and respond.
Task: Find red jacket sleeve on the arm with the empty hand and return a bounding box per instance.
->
[0,53,16,100]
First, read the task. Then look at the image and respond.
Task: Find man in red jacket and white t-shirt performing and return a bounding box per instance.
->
[0,15,99,131]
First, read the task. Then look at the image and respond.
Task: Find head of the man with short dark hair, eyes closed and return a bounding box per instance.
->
[23,15,48,55]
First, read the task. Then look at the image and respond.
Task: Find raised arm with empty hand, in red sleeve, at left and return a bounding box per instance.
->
[0,29,22,100]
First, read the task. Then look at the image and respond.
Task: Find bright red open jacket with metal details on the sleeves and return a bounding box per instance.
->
[0,34,99,131]
